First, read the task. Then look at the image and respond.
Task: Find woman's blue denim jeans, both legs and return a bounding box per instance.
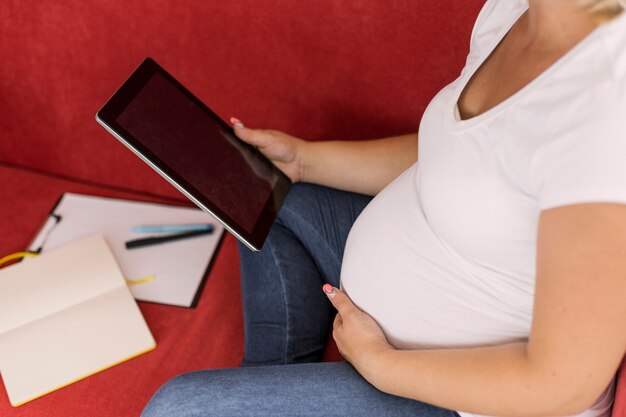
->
[142,184,458,417]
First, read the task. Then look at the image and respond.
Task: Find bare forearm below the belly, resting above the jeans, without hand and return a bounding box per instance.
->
[360,343,599,417]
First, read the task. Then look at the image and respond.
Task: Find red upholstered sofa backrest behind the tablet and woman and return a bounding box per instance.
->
[0,0,484,196]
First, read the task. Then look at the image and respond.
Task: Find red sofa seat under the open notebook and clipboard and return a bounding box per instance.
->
[0,166,243,417]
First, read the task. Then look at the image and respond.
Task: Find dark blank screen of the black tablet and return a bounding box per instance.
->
[116,72,279,233]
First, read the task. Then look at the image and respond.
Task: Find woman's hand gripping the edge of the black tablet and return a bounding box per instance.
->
[230,117,306,182]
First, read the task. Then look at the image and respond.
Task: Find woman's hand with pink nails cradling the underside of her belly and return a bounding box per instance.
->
[323,284,393,382]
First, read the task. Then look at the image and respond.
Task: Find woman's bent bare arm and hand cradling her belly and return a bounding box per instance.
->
[331,204,626,416]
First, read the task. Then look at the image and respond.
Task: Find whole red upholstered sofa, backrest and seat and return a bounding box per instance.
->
[0,0,626,417]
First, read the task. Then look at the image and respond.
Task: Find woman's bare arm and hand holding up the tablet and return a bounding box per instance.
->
[231,119,417,195]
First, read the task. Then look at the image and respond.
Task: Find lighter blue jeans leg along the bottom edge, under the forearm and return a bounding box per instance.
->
[141,362,458,417]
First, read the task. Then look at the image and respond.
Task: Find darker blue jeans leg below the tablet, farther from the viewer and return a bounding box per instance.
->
[239,184,371,366]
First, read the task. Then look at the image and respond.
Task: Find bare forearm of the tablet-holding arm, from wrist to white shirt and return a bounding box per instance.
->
[301,133,417,195]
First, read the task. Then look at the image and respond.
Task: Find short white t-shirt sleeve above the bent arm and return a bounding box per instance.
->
[531,84,626,210]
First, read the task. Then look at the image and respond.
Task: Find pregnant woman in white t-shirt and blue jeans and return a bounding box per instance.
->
[143,0,626,417]
